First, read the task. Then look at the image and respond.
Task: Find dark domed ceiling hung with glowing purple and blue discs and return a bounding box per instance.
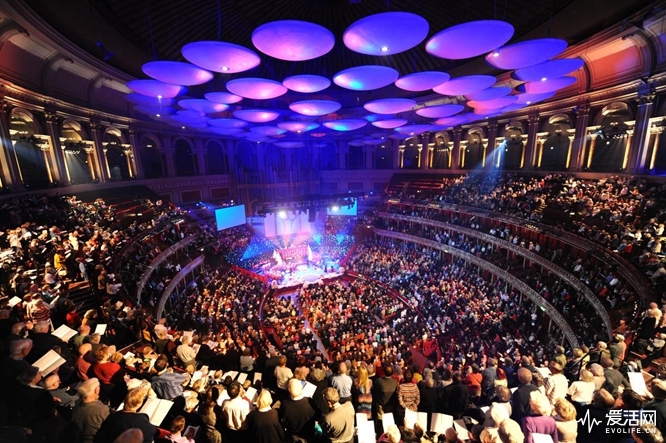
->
[28,0,645,141]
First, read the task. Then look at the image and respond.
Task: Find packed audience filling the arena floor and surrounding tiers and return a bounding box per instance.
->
[0,176,666,443]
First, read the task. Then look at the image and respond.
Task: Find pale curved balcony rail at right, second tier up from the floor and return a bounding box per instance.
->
[378,212,613,337]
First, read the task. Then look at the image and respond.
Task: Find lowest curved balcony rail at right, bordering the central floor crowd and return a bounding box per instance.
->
[374,228,580,348]
